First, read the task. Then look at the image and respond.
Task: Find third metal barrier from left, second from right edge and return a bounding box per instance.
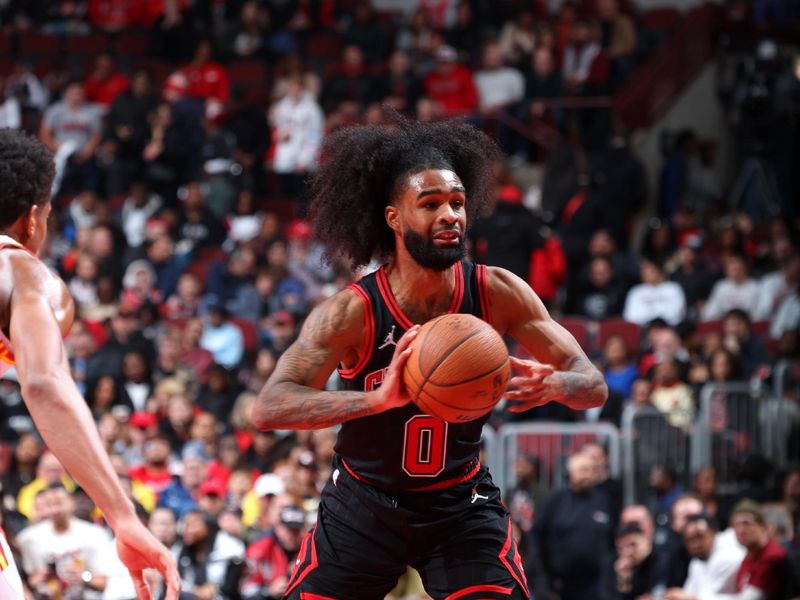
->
[692,383,771,493]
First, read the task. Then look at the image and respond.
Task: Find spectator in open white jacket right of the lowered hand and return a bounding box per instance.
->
[176,510,245,598]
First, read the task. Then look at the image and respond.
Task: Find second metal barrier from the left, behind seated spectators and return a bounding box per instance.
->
[622,404,692,504]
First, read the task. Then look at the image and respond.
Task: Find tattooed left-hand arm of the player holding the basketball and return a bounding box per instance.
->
[253,290,418,430]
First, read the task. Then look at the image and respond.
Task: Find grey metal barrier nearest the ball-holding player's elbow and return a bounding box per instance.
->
[493,422,622,500]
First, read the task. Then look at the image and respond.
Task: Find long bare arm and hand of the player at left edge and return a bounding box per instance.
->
[9,253,180,600]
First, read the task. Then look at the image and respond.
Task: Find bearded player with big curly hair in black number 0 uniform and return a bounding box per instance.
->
[254,116,607,600]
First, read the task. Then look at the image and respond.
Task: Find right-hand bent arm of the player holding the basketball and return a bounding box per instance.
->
[488,268,608,412]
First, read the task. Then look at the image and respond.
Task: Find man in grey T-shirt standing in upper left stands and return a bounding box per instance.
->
[39,80,102,195]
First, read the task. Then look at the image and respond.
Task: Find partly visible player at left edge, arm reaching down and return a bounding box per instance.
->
[0,129,180,600]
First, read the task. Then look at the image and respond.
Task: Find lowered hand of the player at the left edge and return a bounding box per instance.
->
[114,517,181,600]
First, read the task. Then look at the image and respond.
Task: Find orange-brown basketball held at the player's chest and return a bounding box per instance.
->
[403,314,511,423]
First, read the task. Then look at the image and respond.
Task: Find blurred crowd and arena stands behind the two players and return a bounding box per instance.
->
[0,0,800,600]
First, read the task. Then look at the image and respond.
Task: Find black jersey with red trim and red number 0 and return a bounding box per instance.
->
[336,261,491,491]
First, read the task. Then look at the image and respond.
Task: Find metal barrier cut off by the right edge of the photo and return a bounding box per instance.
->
[768,360,800,468]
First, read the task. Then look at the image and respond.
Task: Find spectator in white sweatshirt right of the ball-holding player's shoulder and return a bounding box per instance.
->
[622,259,686,326]
